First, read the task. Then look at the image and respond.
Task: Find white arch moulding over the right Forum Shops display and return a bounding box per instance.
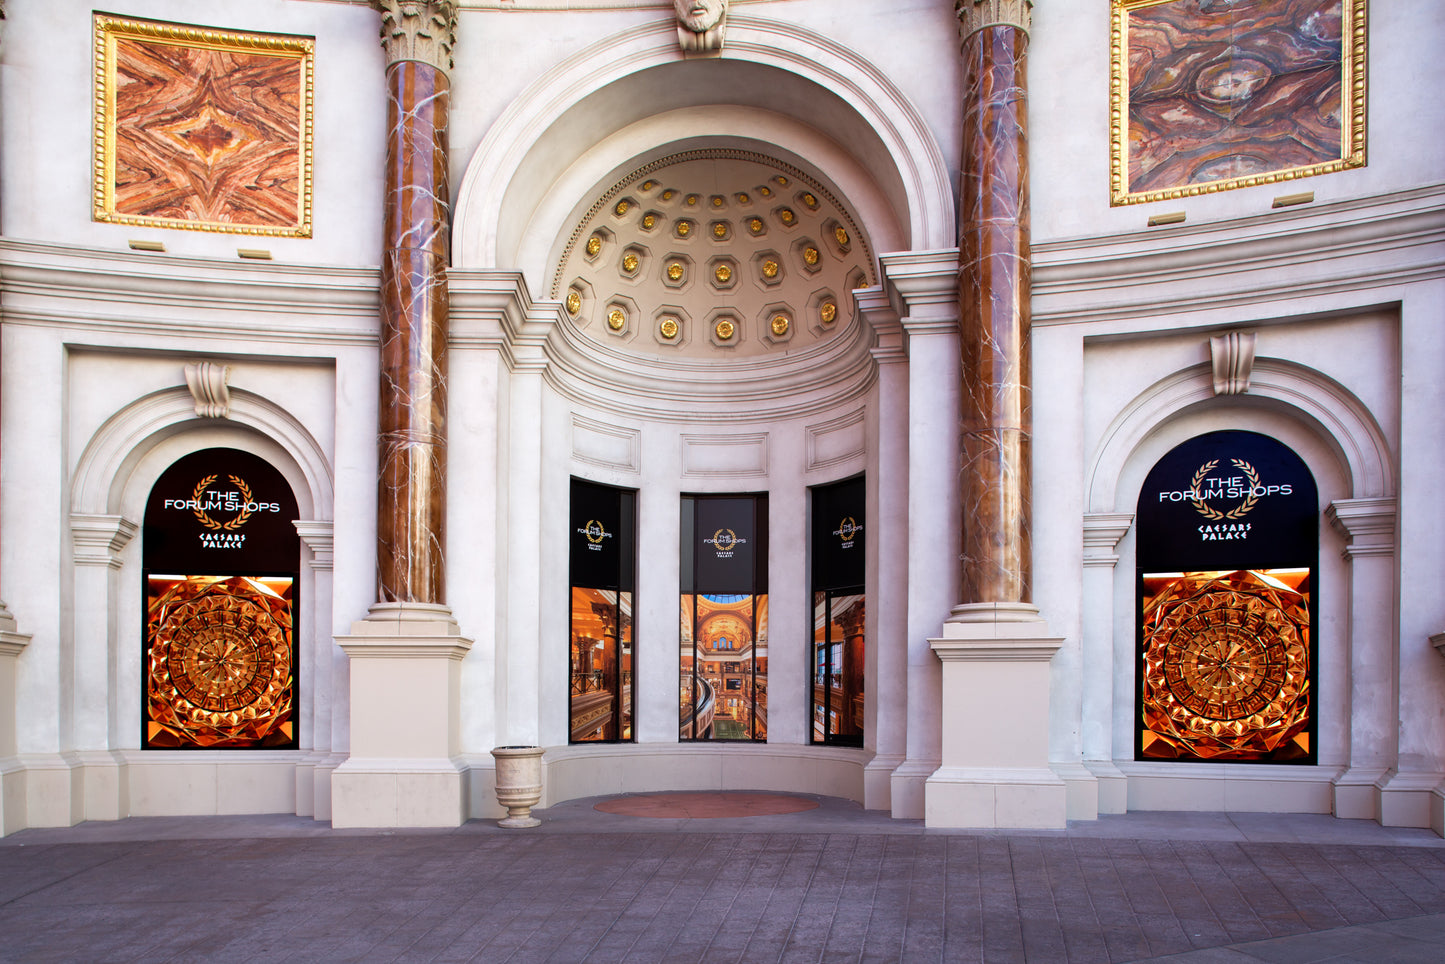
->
[1085,358,1394,513]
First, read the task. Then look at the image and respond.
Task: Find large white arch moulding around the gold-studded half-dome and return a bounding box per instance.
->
[452,17,955,278]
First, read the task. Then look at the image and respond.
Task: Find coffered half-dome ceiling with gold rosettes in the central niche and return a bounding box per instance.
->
[552,150,873,358]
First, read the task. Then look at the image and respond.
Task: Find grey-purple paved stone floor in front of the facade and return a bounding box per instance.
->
[0,798,1445,964]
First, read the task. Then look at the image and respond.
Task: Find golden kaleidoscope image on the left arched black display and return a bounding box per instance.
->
[145,575,296,749]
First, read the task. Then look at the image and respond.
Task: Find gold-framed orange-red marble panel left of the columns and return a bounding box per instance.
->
[94,14,315,237]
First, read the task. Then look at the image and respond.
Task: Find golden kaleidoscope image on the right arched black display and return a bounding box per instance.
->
[1140,569,1314,762]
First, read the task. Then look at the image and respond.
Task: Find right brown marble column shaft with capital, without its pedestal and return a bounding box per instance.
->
[955,0,1032,606]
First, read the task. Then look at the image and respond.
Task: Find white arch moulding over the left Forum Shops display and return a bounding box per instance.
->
[71,386,332,519]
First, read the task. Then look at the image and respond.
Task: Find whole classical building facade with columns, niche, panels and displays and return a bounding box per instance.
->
[0,0,1445,832]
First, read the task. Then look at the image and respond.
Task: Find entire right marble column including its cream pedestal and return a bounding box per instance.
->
[923,0,1068,828]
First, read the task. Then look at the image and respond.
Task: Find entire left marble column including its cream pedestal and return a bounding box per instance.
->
[330,0,471,827]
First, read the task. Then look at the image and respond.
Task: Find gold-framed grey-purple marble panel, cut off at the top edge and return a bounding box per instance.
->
[1110,0,1366,205]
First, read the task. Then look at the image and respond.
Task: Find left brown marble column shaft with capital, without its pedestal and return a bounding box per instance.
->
[376,0,457,604]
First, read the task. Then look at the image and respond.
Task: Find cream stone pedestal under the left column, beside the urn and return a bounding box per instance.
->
[331,604,471,827]
